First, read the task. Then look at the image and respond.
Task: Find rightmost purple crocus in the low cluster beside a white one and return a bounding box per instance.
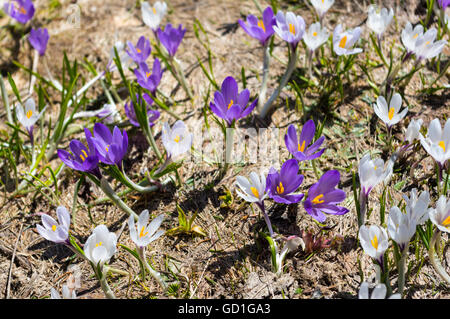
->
[303,170,349,223]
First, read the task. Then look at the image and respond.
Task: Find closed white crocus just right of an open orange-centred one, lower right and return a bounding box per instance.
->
[387,206,417,251]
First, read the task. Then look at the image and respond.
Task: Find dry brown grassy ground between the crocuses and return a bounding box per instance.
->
[0,0,450,299]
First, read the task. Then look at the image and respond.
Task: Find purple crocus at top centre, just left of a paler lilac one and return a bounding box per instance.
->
[239,7,276,46]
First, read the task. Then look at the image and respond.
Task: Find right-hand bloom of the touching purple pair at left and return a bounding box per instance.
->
[92,123,128,168]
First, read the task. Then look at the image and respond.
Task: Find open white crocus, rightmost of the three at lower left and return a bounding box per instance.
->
[128,209,164,247]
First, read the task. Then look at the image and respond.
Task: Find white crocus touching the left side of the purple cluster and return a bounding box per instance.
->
[236,172,267,204]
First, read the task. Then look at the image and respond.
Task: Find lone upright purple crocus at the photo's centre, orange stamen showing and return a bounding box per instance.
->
[210,76,258,126]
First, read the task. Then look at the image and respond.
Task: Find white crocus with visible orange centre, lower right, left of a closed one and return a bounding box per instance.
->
[359,225,389,265]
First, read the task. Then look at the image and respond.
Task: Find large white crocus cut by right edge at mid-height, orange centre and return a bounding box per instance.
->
[419,119,450,167]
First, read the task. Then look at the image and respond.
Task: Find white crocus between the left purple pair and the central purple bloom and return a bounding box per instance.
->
[161,120,193,160]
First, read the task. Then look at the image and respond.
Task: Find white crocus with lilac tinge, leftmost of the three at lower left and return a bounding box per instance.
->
[36,206,70,244]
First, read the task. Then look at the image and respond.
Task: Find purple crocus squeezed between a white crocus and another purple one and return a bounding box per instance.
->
[266,158,304,204]
